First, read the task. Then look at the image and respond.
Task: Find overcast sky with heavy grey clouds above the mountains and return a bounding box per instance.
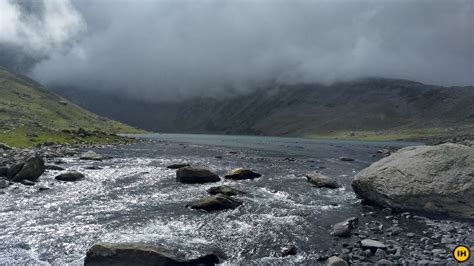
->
[0,0,474,100]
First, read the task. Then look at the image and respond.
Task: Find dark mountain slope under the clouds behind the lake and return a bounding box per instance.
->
[51,79,474,136]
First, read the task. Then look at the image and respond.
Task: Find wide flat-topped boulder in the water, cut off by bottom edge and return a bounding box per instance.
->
[84,243,220,266]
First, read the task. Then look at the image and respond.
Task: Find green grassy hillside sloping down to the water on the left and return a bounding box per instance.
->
[0,67,140,147]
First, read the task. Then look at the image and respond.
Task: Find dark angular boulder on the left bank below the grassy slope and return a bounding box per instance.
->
[8,155,44,182]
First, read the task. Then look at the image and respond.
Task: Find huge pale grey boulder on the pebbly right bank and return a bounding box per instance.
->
[352,143,474,219]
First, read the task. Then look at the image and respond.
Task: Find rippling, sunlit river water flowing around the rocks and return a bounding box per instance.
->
[0,134,466,264]
